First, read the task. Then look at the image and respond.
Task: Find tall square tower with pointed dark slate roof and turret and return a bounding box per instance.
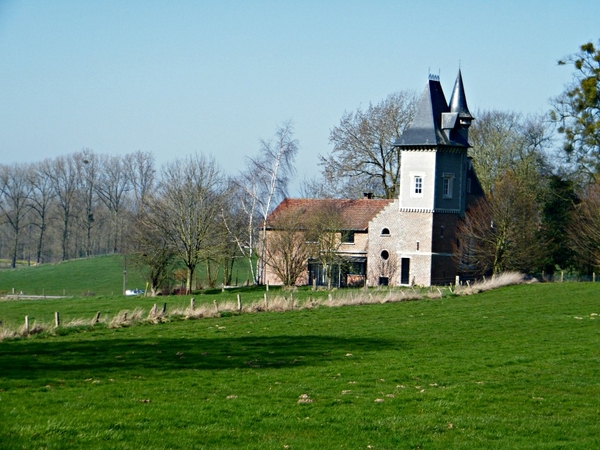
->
[394,70,473,286]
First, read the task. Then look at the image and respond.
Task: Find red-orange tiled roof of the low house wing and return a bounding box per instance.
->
[267,198,393,231]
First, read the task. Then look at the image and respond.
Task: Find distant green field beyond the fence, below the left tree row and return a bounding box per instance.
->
[0,255,254,296]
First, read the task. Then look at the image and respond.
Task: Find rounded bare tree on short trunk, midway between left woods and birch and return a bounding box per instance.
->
[147,155,223,293]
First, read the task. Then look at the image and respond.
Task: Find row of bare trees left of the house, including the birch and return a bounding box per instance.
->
[0,122,298,293]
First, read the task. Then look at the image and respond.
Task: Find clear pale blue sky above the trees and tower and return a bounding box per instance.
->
[0,0,600,193]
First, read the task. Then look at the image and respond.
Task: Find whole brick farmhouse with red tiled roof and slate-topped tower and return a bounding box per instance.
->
[264,71,483,286]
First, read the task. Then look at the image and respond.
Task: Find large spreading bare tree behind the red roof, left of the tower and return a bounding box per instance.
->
[320,91,418,198]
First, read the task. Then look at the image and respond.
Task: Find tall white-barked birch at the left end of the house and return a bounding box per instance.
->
[237,121,298,283]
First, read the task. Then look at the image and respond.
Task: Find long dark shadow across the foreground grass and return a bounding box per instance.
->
[0,335,407,380]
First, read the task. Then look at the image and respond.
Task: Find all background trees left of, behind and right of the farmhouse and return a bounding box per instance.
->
[0,43,600,292]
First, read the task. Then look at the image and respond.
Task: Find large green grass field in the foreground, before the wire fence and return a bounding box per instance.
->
[0,283,600,449]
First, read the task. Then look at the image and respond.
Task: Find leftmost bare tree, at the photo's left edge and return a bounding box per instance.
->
[0,164,32,269]
